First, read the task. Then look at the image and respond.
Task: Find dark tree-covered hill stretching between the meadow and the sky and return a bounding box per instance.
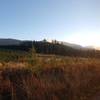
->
[0,41,100,58]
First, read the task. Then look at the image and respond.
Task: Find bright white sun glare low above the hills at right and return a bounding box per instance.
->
[67,33,100,48]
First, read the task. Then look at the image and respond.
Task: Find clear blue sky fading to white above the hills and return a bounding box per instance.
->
[0,0,100,46]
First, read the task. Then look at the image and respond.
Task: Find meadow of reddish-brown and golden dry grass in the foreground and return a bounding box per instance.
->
[0,50,100,100]
